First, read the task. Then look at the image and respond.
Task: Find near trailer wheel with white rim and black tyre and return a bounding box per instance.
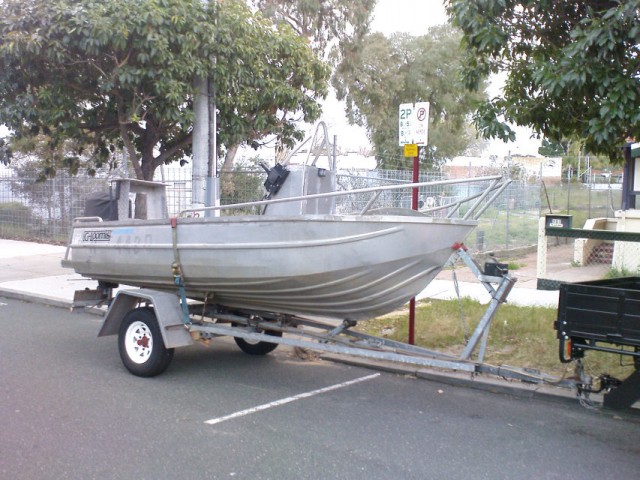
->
[118,308,173,377]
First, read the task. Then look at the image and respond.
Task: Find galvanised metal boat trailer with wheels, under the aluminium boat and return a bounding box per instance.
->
[78,248,596,402]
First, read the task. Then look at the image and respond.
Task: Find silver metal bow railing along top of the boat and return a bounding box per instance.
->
[179,175,511,220]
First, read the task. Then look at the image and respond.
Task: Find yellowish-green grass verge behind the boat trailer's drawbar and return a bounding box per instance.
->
[358,298,633,379]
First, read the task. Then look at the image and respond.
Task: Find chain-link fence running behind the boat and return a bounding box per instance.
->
[0,166,632,272]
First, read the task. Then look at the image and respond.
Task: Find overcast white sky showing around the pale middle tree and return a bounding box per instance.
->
[323,0,540,157]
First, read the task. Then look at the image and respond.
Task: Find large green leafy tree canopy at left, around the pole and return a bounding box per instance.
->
[0,0,328,184]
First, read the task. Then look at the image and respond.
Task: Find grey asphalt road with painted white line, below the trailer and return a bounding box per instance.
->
[0,298,640,480]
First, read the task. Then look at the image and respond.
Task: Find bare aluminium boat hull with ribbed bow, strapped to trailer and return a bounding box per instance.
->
[65,215,476,320]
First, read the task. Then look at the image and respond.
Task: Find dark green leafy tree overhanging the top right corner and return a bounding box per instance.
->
[447,0,640,160]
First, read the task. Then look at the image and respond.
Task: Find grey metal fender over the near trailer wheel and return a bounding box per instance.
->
[98,288,193,348]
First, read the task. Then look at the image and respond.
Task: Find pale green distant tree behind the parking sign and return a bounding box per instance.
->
[333,26,482,169]
